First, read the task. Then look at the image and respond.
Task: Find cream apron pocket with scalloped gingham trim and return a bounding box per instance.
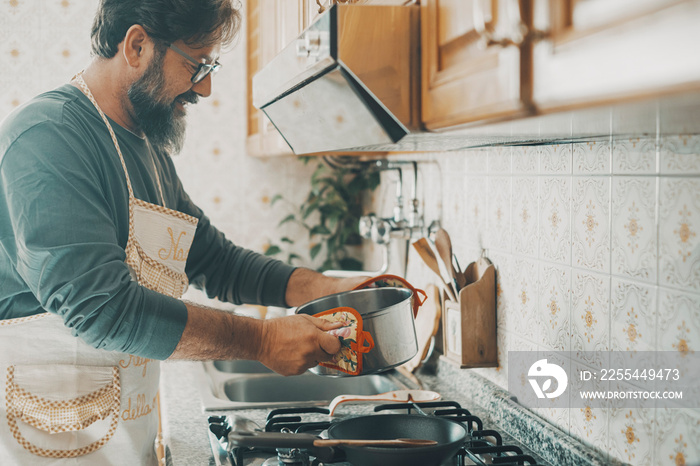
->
[5,364,121,458]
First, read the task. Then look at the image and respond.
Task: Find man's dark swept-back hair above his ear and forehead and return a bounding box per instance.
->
[91,0,241,58]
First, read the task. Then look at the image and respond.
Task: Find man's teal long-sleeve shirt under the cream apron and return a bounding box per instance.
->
[0,85,294,359]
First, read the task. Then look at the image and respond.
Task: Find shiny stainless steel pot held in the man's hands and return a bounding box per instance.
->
[296,288,418,377]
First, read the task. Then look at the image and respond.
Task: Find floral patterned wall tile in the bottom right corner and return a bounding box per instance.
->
[653,408,700,465]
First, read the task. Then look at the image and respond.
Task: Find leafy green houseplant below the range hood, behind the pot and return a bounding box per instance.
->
[265,157,380,271]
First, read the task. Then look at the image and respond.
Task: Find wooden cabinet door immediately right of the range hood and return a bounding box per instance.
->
[421,0,530,130]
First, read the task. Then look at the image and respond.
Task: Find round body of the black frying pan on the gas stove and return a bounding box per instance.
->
[328,414,467,466]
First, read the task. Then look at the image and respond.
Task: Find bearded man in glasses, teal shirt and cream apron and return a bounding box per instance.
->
[0,0,362,465]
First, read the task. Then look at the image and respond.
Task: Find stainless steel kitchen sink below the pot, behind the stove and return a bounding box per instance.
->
[199,360,418,410]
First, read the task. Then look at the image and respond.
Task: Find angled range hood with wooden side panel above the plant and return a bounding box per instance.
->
[253,4,420,154]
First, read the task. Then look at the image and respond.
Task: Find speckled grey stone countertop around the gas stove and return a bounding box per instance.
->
[161,358,620,466]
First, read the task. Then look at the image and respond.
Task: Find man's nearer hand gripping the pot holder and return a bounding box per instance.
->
[256,314,341,375]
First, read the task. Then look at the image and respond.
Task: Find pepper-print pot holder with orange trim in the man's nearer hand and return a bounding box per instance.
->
[314,307,374,375]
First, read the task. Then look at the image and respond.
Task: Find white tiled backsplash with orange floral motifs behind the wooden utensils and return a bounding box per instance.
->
[388,139,700,465]
